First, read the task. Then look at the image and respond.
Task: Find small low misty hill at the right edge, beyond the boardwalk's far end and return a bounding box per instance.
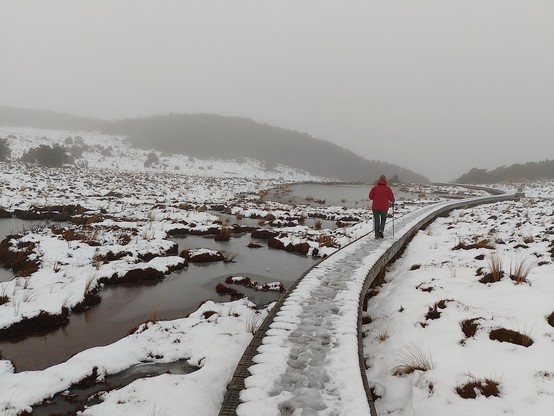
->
[454,160,554,184]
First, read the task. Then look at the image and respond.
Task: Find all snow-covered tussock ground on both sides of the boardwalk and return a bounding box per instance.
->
[0,128,554,416]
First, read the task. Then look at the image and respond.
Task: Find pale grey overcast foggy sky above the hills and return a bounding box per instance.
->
[0,0,554,181]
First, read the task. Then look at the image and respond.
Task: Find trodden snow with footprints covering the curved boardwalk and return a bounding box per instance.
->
[220,197,507,416]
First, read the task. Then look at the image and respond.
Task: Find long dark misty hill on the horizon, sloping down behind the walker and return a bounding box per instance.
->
[0,107,429,183]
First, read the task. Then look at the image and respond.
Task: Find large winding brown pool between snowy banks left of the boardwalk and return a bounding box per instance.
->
[0,231,316,371]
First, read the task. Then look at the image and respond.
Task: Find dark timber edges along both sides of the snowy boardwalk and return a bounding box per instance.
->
[219,185,515,416]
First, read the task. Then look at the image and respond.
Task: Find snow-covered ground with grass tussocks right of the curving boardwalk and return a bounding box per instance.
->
[364,190,554,416]
